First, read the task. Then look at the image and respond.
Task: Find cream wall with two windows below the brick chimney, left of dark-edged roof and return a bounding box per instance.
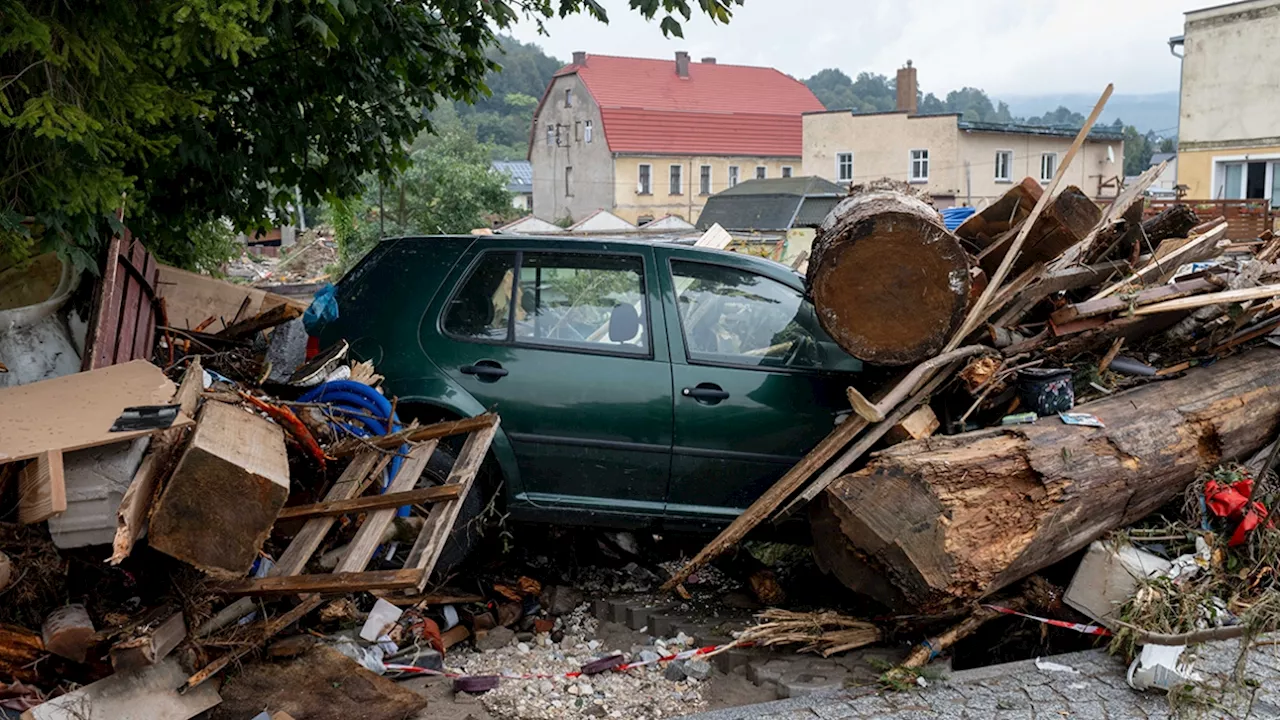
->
[804,111,964,202]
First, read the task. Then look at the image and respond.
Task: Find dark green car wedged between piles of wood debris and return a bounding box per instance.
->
[320,236,861,532]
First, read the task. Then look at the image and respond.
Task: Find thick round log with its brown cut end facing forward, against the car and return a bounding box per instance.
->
[808,181,969,365]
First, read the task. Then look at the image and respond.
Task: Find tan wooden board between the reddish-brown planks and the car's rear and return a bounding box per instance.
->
[156,265,308,333]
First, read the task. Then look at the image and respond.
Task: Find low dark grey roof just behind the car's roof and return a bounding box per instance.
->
[698,177,846,231]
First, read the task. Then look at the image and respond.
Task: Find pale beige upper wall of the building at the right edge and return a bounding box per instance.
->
[1178,0,1280,151]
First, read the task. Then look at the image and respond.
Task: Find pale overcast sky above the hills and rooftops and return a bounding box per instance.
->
[513,0,1198,97]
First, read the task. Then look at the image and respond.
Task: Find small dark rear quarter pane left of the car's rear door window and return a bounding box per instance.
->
[444,252,520,342]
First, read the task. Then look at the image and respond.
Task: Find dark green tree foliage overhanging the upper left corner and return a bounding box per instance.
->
[0,0,741,270]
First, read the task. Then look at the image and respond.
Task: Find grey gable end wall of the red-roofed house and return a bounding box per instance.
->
[529,74,613,223]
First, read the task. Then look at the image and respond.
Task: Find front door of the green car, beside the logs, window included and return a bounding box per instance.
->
[655,249,861,523]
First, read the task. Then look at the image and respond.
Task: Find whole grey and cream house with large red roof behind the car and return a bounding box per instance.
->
[529,53,823,225]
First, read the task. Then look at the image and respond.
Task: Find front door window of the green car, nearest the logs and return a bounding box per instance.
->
[671,260,861,372]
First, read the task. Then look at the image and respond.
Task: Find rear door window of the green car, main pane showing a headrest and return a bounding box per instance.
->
[515,252,649,355]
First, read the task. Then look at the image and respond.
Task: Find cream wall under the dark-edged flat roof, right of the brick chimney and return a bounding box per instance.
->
[956,131,1124,209]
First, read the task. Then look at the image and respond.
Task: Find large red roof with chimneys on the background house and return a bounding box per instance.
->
[534,55,822,158]
